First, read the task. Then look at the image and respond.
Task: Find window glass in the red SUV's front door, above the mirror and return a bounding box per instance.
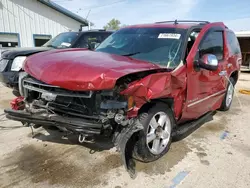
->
[199,31,224,60]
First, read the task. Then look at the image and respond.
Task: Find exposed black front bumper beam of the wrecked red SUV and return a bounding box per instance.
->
[4,109,103,134]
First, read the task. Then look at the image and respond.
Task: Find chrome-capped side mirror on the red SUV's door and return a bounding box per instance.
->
[198,54,218,71]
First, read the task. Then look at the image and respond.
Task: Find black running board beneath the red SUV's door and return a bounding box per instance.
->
[172,111,215,141]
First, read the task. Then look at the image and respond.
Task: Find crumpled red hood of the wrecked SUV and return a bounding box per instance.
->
[24,49,160,91]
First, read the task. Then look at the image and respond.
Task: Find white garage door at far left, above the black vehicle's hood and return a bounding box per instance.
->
[0,33,20,48]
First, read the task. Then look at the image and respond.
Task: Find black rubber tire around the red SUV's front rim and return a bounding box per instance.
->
[133,103,175,163]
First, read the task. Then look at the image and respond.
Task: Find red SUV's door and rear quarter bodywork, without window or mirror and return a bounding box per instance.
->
[182,22,240,121]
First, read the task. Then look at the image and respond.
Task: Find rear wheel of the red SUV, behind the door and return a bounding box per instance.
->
[219,77,235,111]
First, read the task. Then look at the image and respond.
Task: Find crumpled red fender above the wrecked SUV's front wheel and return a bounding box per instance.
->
[121,66,186,119]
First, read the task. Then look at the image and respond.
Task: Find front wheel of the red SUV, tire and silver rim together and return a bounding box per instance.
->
[133,103,175,162]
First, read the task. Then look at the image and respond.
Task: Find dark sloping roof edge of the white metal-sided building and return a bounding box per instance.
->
[37,0,88,26]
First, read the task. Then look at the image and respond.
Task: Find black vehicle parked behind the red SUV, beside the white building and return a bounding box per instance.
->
[0,30,112,96]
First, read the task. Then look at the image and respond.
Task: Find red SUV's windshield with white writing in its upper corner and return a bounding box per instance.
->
[96,28,187,68]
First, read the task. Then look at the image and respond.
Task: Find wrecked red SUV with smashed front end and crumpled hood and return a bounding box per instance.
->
[5,21,241,178]
